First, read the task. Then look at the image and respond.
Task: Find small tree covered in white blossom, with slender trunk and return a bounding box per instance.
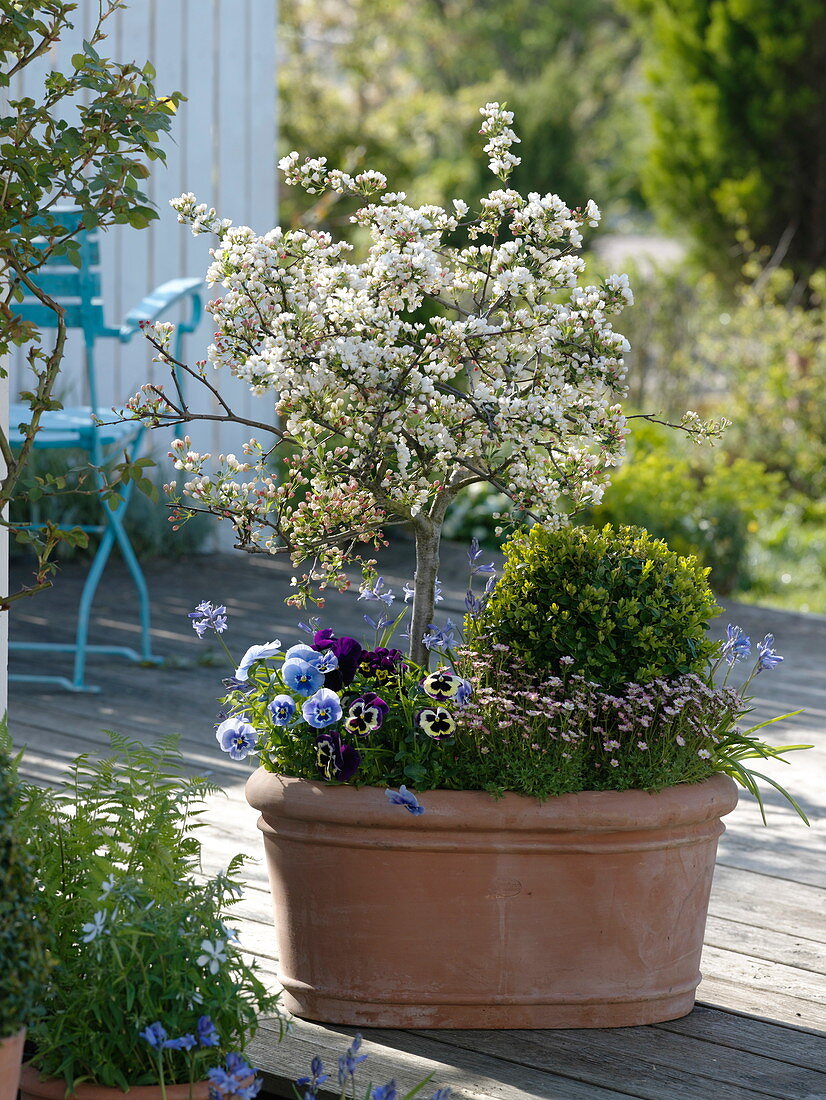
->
[128,103,632,666]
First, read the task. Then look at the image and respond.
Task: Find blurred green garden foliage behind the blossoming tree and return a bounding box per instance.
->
[279,0,826,612]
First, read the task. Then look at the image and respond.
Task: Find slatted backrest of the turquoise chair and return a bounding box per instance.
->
[13,208,120,409]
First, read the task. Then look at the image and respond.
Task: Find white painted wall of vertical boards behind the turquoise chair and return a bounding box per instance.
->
[10,0,277,458]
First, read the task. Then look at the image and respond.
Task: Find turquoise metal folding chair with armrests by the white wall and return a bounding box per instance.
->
[9,210,203,692]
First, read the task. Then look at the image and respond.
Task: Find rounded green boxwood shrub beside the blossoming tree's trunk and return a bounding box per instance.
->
[470,524,718,688]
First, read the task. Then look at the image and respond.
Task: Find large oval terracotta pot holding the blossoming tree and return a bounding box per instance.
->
[246,768,737,1027]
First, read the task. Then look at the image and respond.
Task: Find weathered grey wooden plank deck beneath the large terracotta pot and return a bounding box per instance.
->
[10,546,826,1100]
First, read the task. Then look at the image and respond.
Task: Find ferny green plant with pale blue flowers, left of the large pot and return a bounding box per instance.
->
[21,735,277,1096]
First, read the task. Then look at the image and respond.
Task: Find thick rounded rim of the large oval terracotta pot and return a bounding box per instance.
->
[246,767,738,832]
